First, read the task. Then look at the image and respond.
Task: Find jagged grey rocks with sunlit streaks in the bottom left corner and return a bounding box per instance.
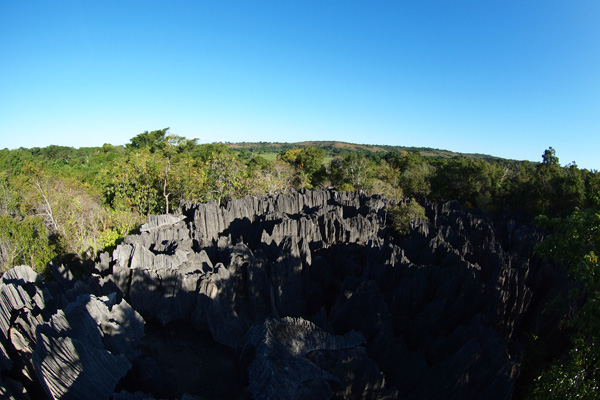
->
[0,266,144,399]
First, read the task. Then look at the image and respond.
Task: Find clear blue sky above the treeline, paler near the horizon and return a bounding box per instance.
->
[0,0,600,169]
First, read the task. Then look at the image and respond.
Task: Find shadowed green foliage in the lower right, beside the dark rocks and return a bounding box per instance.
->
[532,199,600,399]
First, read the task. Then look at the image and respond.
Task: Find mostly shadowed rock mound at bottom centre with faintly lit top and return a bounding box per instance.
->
[242,317,398,400]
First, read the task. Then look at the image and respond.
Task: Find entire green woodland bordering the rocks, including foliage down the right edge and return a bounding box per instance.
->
[0,128,600,398]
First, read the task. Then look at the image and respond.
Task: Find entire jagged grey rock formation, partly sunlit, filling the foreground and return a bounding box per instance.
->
[0,191,556,399]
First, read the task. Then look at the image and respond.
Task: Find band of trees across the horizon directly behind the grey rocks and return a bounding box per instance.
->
[0,135,600,278]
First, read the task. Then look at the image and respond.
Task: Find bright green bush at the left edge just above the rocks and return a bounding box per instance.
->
[0,215,55,273]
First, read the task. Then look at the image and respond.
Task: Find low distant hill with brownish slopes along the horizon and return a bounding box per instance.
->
[225,141,504,161]
